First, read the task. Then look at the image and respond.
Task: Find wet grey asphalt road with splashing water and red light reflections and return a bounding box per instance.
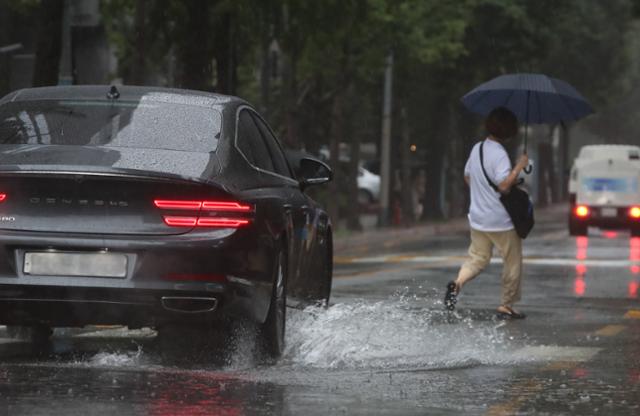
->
[0,206,640,415]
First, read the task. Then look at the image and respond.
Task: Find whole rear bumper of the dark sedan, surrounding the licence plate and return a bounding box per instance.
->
[0,230,275,327]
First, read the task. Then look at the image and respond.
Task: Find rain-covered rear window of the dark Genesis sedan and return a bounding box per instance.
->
[0,100,222,152]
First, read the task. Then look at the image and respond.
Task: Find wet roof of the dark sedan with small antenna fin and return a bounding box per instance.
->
[0,85,247,107]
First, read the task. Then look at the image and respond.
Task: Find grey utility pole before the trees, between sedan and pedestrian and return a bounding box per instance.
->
[378,51,393,226]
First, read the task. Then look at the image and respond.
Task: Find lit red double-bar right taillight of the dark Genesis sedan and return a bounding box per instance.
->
[153,199,253,228]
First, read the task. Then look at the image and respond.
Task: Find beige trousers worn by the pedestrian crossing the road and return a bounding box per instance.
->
[456,228,522,307]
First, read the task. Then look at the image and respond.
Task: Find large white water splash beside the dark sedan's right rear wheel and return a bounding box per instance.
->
[282,298,510,369]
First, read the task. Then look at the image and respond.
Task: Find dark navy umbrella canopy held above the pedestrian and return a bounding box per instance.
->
[462,74,593,124]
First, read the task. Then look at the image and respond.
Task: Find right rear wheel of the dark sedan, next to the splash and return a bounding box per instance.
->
[258,251,287,359]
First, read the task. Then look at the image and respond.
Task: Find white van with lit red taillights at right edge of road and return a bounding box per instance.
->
[569,145,640,236]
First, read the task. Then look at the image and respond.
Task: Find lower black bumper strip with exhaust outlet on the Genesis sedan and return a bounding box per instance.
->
[0,285,241,328]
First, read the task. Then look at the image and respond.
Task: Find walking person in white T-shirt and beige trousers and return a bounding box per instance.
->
[444,107,529,319]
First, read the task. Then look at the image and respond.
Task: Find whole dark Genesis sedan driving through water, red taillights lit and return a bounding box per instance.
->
[0,86,332,356]
